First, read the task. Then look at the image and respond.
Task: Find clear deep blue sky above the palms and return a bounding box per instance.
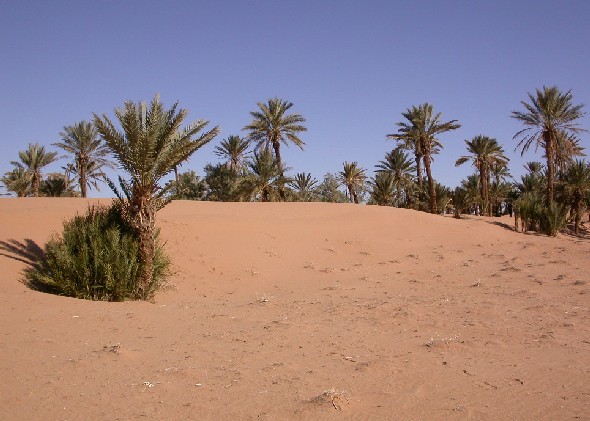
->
[0,0,590,196]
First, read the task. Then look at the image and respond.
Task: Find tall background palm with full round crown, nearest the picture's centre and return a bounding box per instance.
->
[244,97,307,200]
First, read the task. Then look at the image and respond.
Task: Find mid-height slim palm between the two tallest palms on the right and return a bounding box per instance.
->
[455,135,508,216]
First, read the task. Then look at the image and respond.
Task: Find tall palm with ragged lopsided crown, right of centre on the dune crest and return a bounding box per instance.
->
[394,103,461,213]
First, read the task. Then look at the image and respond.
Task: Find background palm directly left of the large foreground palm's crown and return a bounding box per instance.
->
[53,121,112,197]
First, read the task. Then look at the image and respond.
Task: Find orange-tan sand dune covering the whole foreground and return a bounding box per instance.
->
[0,199,590,420]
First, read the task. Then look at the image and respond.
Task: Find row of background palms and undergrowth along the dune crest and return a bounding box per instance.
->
[2,86,590,234]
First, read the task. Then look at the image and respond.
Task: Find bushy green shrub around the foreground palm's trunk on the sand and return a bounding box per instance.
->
[25,204,170,301]
